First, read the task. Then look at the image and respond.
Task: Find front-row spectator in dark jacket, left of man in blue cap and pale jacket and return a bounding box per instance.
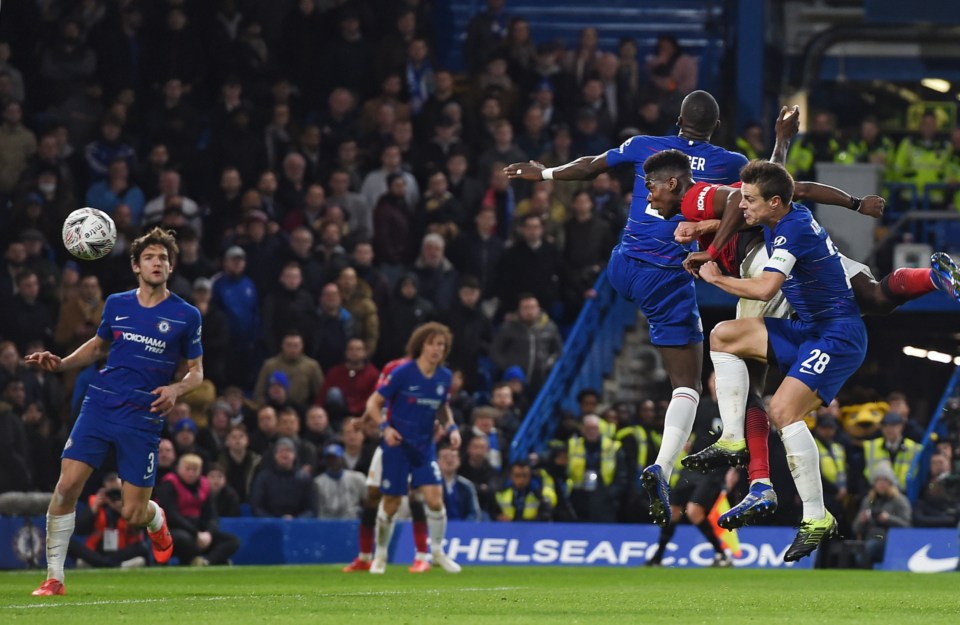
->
[250,438,317,519]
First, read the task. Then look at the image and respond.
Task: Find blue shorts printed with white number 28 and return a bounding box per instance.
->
[763,317,867,405]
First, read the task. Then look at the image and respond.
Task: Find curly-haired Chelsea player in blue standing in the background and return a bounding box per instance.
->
[364,322,460,574]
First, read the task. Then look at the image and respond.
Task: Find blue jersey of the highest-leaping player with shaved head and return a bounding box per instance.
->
[606,135,747,268]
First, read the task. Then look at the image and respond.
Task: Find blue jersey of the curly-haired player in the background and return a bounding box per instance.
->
[377,360,453,449]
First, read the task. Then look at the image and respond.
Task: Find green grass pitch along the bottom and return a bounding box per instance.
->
[0,565,960,625]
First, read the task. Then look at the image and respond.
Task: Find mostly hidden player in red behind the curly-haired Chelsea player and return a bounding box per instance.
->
[343,357,430,573]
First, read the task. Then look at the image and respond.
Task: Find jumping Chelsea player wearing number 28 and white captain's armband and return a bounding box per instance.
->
[700,161,867,562]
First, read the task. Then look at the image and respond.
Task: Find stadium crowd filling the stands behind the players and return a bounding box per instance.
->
[0,0,960,563]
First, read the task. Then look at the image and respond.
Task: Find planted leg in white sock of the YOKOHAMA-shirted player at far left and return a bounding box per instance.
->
[32,458,93,597]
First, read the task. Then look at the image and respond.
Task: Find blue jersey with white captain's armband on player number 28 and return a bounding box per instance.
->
[763,204,860,323]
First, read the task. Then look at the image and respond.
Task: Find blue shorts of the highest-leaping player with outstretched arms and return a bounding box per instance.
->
[607,245,703,347]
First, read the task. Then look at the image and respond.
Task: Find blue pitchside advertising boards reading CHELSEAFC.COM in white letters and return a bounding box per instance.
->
[0,516,958,572]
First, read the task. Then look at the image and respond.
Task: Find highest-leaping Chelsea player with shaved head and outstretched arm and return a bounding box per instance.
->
[504,91,747,527]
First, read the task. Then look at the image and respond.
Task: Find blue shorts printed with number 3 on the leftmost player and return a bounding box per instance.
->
[61,396,160,488]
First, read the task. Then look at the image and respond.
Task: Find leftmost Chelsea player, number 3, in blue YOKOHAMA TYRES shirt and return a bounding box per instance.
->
[26,228,203,596]
